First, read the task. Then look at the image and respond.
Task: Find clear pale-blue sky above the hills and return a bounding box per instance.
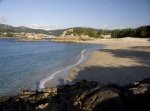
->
[0,0,150,30]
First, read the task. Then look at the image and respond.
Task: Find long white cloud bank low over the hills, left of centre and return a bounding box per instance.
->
[24,23,58,30]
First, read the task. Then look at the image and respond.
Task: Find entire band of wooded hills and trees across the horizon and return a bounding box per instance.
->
[0,24,150,38]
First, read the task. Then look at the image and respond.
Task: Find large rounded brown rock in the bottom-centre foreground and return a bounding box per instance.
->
[70,87,125,111]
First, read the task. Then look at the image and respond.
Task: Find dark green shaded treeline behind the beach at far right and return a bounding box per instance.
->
[111,26,150,38]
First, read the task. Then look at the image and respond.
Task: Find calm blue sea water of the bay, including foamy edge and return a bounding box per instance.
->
[0,39,103,96]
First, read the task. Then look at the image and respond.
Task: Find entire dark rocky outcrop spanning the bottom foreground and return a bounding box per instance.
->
[0,78,150,111]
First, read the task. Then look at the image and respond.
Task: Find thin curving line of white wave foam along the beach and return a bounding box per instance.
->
[39,49,86,90]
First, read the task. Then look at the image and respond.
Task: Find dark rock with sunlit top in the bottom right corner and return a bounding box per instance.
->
[121,79,150,111]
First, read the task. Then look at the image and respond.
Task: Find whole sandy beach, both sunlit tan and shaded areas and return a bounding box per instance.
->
[64,37,150,85]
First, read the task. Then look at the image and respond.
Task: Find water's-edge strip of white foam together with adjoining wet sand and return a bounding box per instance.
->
[40,47,102,89]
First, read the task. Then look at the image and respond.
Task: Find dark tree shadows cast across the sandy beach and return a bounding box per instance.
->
[65,46,150,85]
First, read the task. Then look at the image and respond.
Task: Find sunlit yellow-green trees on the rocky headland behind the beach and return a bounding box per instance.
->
[66,28,110,38]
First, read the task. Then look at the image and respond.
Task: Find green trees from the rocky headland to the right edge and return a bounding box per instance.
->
[63,25,150,38]
